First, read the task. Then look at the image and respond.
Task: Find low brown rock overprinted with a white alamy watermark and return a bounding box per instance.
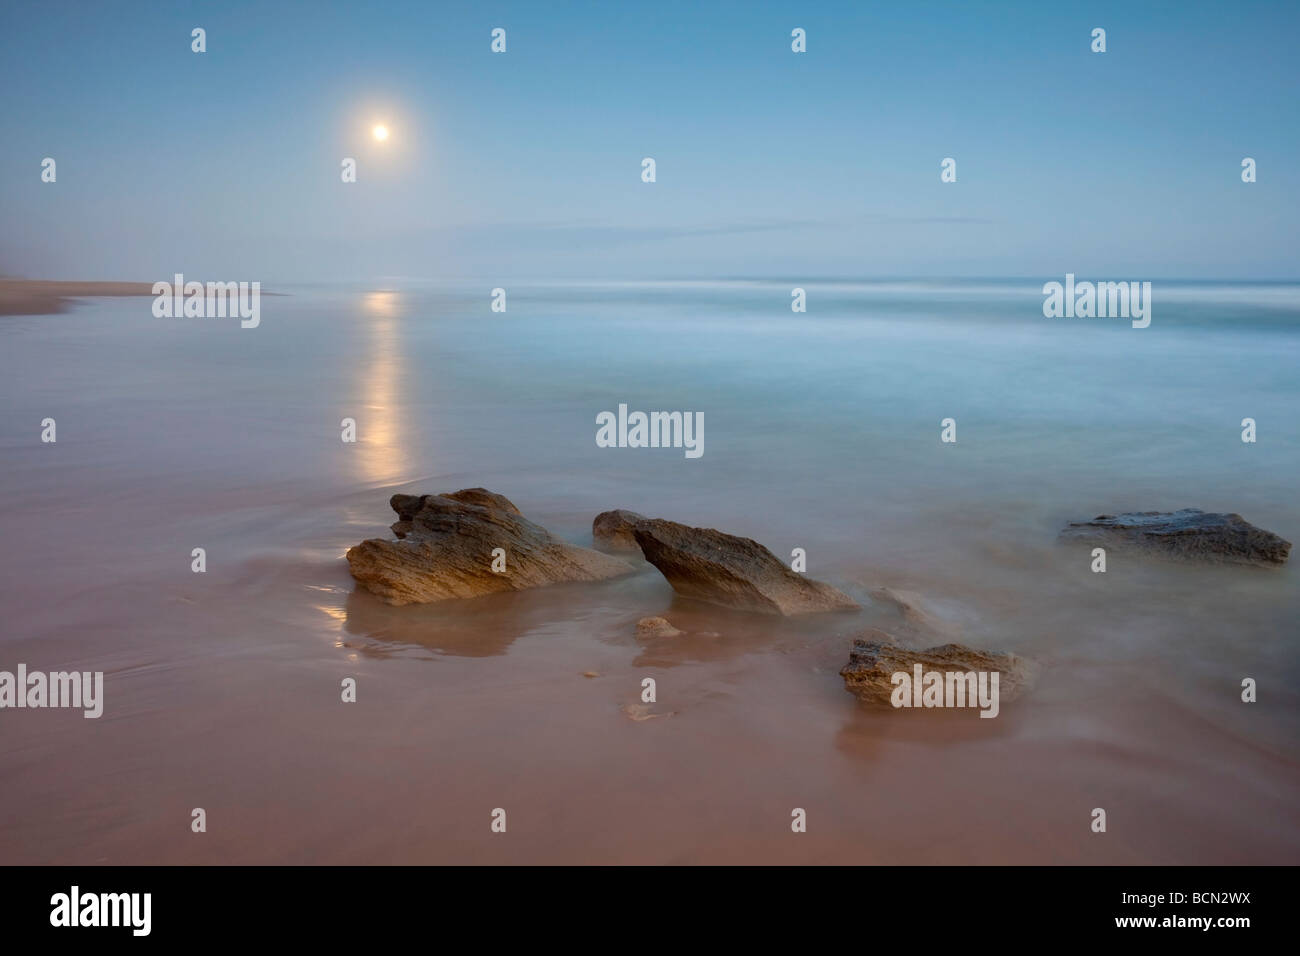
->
[840,628,1032,709]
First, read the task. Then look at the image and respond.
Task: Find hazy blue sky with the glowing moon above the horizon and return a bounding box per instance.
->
[0,0,1300,282]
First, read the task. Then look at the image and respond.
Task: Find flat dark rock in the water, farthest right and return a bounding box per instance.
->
[1061,507,1291,567]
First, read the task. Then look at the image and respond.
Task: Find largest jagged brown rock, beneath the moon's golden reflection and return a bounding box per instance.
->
[347,488,633,605]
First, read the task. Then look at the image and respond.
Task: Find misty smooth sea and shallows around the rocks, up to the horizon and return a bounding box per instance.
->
[0,282,1300,864]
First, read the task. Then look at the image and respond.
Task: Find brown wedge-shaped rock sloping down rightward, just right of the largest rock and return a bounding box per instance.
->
[633,519,858,615]
